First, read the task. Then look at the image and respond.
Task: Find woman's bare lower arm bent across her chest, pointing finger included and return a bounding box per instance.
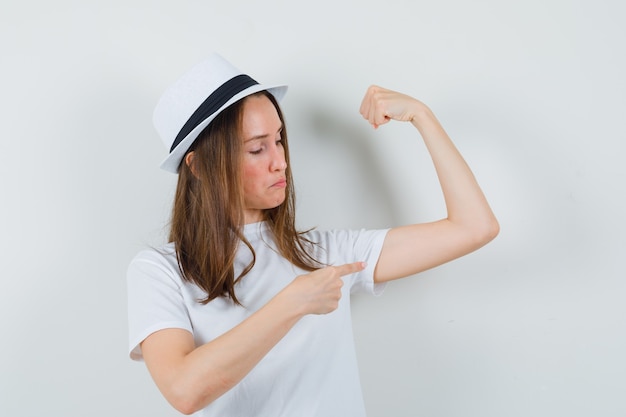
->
[141,262,365,414]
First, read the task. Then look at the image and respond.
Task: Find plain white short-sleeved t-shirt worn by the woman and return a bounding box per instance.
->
[128,222,387,417]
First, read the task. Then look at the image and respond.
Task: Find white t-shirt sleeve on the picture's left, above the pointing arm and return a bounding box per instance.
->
[127,250,192,360]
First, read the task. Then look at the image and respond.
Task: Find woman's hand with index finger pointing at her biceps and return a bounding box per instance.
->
[287,262,366,314]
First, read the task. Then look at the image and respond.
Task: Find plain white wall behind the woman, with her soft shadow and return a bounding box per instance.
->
[0,0,626,417]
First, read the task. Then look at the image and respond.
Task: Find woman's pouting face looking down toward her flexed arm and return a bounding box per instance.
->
[242,95,287,223]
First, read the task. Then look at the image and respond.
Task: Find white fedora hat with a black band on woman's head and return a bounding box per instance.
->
[153,53,287,173]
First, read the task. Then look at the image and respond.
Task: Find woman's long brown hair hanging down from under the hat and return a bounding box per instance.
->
[170,91,321,305]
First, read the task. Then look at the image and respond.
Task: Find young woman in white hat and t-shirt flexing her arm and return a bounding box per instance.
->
[128,55,499,417]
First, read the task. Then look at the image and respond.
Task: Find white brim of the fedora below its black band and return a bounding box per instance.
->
[161,84,287,174]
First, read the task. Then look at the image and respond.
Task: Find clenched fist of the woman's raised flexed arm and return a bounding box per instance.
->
[359,85,425,128]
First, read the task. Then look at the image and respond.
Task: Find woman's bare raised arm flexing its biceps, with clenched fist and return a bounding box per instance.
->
[360,86,500,282]
